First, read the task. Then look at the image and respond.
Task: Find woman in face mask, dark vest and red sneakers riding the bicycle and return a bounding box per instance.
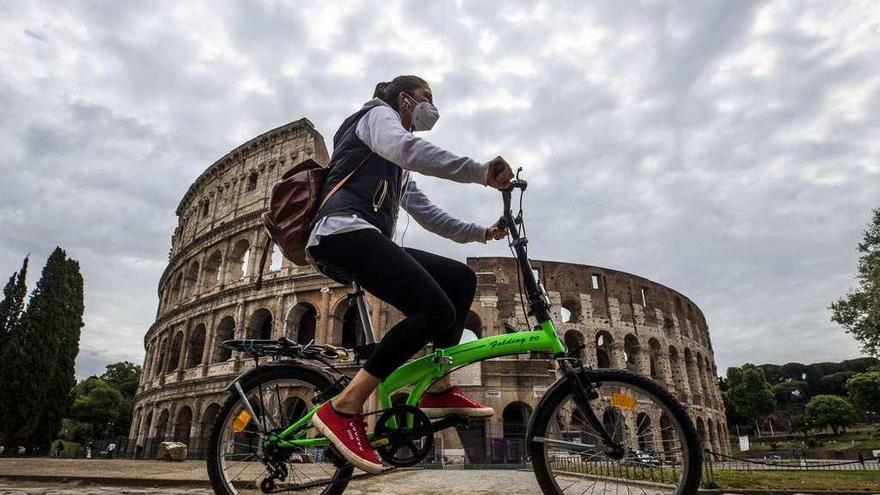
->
[307,76,513,472]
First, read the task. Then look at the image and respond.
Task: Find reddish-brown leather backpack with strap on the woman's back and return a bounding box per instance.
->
[254,157,372,290]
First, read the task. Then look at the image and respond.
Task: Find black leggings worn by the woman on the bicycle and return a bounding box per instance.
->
[309,229,477,380]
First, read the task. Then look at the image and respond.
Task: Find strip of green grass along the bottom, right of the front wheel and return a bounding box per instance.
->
[715,469,880,493]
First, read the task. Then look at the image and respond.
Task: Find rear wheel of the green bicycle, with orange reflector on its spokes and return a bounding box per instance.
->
[208,366,354,495]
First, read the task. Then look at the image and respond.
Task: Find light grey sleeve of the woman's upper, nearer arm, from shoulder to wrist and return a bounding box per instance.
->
[355,104,489,186]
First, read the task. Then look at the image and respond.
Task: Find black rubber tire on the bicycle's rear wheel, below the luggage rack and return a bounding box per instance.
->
[207,366,354,495]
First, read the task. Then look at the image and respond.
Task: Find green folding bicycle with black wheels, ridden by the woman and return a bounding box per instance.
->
[207,172,702,495]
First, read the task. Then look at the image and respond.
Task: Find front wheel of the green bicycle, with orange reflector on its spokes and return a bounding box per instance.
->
[529,369,702,495]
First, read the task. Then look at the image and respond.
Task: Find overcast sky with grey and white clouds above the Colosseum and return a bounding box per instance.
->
[0,0,880,378]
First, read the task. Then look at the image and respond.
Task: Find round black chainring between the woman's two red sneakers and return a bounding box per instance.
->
[373,405,434,467]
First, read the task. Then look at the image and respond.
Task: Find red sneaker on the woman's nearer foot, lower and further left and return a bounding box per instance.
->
[312,401,382,473]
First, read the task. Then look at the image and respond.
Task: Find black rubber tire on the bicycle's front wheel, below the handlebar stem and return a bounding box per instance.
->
[528,369,703,495]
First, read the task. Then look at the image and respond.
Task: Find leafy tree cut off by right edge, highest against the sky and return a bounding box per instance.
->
[830,208,880,357]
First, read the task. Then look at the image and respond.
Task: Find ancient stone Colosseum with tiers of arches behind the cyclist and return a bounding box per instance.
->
[129,119,730,462]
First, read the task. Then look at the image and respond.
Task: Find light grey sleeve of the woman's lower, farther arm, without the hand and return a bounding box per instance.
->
[400,179,486,243]
